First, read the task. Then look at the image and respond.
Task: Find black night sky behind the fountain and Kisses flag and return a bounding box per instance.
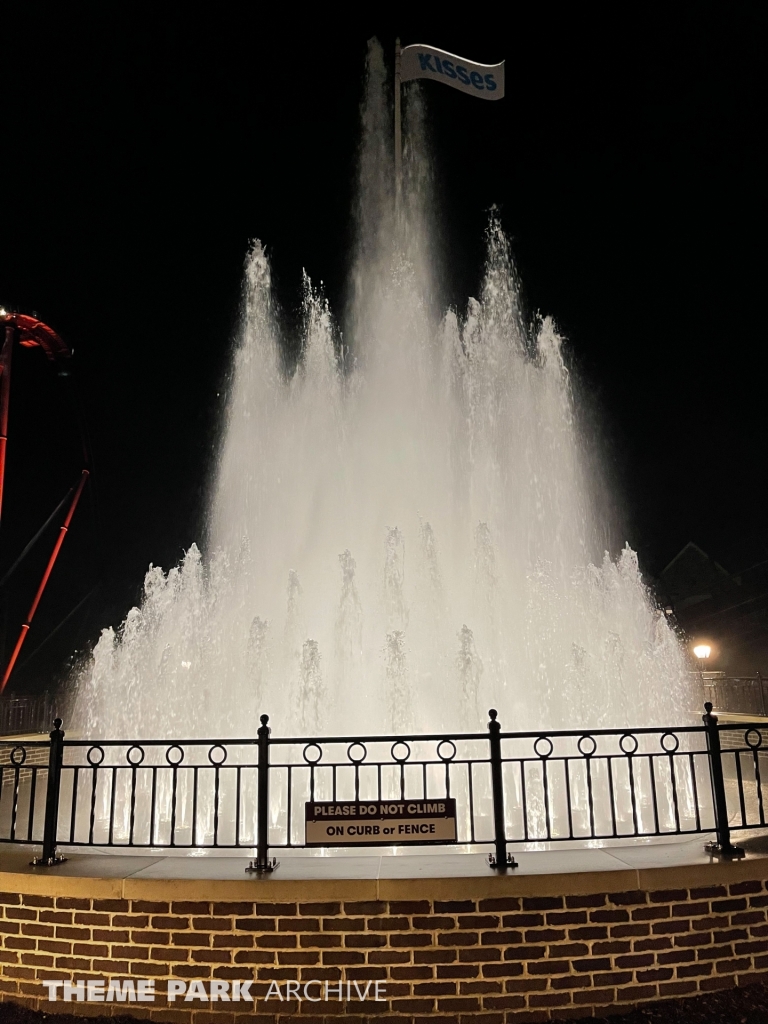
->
[0,3,768,691]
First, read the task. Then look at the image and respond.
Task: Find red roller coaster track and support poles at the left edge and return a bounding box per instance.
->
[0,308,88,693]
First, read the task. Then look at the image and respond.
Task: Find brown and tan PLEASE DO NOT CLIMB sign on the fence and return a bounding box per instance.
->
[304,797,456,846]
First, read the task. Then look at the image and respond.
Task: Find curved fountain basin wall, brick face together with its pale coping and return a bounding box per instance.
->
[0,837,768,1024]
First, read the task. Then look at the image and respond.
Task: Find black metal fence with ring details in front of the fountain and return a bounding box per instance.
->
[0,703,768,871]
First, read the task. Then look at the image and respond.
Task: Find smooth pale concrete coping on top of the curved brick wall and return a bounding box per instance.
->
[0,836,768,902]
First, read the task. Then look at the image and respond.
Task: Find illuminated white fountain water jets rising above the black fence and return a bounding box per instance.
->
[78,44,688,736]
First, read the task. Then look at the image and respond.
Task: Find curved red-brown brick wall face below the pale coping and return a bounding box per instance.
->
[0,872,768,1024]
